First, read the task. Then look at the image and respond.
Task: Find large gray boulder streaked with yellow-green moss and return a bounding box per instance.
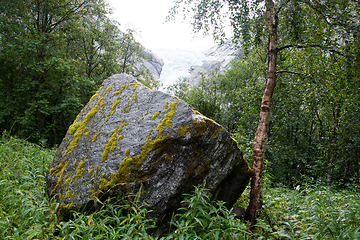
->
[46,74,250,229]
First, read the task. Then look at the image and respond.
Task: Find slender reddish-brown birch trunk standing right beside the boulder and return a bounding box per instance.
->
[245,0,277,229]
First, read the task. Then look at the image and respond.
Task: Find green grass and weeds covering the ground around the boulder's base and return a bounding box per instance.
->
[0,133,360,240]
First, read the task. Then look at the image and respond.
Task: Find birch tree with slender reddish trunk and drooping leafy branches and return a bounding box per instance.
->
[169,0,360,227]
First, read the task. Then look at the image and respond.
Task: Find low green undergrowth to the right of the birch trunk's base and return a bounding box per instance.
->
[264,186,360,239]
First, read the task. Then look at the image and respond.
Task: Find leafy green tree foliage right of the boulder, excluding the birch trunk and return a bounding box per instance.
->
[166,0,360,187]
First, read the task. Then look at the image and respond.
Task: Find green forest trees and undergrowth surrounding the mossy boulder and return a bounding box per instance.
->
[0,0,360,239]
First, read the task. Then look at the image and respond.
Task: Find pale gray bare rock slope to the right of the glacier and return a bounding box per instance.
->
[186,40,242,86]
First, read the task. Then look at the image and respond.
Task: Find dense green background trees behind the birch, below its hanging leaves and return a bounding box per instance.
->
[168,47,360,188]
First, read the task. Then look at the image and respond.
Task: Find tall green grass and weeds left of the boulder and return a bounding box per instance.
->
[0,133,54,239]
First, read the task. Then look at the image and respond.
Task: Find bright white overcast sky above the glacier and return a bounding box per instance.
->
[108,0,215,51]
